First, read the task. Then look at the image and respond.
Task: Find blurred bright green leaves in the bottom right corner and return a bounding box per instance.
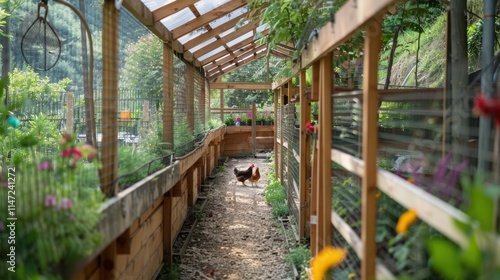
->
[427,176,500,279]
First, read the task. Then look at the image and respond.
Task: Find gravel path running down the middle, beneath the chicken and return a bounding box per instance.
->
[180,158,290,280]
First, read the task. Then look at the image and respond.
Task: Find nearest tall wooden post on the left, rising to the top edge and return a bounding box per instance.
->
[100,0,119,197]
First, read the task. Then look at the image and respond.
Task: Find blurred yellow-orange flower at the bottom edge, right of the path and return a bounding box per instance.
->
[311,246,347,280]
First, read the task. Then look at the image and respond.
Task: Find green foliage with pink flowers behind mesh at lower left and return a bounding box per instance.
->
[0,134,103,279]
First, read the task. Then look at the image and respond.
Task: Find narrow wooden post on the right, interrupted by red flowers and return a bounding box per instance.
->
[310,62,320,257]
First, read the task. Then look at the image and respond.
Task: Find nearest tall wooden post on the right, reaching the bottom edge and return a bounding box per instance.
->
[361,20,381,279]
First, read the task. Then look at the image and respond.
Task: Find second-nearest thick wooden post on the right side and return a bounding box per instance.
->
[318,52,333,251]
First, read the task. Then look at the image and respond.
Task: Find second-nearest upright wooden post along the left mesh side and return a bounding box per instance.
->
[162,43,174,151]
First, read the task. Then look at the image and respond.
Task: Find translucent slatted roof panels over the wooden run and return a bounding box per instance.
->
[136,0,268,79]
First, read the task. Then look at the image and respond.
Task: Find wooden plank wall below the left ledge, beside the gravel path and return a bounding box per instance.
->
[71,130,223,280]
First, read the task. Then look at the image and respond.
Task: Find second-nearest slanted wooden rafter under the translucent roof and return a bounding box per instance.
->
[172,0,247,39]
